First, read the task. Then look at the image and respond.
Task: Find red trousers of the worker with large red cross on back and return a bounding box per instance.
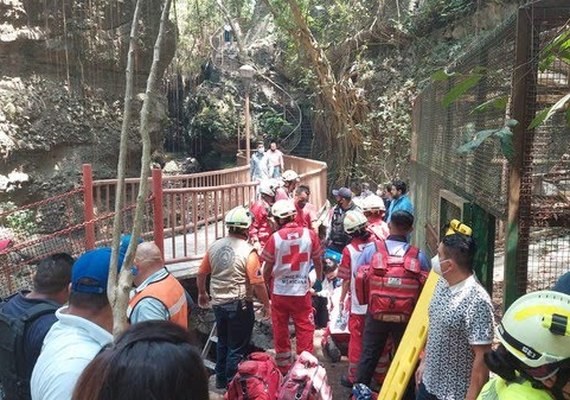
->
[271,293,315,372]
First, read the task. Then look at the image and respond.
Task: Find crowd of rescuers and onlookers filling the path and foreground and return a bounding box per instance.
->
[0,150,570,400]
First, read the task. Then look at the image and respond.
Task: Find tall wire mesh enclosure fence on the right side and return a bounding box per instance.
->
[411,0,570,310]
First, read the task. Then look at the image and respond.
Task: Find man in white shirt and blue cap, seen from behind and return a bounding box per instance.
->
[30,248,123,400]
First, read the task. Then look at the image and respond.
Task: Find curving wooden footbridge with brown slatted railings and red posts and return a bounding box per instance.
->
[0,156,327,297]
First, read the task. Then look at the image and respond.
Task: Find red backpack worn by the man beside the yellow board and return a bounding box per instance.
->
[355,241,427,322]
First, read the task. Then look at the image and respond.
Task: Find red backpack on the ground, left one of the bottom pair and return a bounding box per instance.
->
[224,352,283,400]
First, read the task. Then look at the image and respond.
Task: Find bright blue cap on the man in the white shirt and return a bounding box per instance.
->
[71,247,125,294]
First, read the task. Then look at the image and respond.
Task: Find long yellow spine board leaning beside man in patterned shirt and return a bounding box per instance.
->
[378,272,439,400]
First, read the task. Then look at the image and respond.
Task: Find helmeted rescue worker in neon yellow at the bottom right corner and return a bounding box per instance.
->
[478,290,570,400]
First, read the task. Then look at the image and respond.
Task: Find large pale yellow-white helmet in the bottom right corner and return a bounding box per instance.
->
[497,290,570,368]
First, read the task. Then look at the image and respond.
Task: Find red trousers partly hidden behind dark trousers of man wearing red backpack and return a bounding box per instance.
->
[348,314,395,384]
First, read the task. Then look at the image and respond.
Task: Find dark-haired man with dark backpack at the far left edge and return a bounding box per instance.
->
[0,253,73,399]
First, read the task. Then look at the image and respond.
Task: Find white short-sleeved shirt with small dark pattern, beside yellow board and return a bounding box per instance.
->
[422,275,494,400]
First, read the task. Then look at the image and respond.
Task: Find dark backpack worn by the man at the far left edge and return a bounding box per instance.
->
[0,293,61,400]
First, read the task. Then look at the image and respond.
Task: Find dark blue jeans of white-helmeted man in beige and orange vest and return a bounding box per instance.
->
[213,300,255,384]
